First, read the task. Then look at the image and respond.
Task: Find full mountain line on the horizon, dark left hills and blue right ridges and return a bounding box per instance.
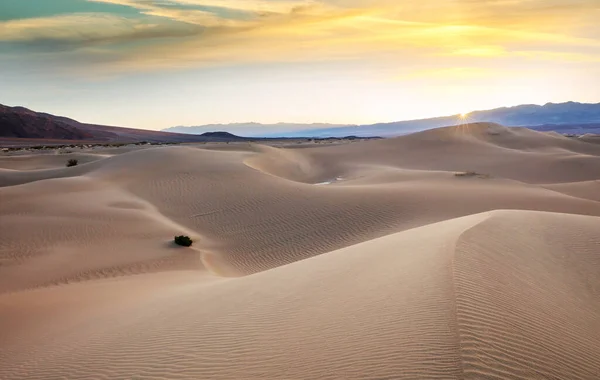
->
[0,102,600,143]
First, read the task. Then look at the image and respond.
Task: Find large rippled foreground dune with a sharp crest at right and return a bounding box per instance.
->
[0,211,600,379]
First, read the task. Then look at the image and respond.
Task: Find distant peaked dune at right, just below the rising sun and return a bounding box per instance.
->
[305,123,600,184]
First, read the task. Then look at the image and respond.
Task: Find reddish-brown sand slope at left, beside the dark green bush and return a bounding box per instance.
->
[0,177,206,291]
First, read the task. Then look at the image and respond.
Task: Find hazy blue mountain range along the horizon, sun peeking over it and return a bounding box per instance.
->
[165,102,600,137]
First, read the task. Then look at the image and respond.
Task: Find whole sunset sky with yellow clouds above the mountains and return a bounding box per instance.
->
[0,0,600,130]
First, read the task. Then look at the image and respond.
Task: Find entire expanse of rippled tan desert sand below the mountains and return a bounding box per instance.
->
[0,123,600,379]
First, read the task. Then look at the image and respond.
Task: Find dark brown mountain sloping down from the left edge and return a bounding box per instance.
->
[0,104,242,142]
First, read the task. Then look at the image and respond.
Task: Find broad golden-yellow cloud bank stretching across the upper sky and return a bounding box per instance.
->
[0,0,600,73]
